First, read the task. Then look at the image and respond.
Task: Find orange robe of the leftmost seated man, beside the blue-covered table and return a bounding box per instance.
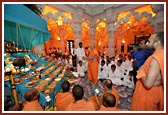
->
[22,100,44,111]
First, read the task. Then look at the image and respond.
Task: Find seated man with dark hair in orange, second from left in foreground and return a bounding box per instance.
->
[56,81,74,111]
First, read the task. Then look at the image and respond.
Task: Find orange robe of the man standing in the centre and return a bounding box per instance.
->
[88,49,99,84]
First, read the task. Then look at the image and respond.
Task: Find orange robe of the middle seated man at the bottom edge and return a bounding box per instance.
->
[65,99,96,111]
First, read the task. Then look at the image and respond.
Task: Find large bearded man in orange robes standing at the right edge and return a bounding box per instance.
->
[131,32,164,111]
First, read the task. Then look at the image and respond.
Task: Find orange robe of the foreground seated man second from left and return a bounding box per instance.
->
[56,92,74,111]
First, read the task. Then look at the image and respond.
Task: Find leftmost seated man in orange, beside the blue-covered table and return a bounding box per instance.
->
[22,88,43,111]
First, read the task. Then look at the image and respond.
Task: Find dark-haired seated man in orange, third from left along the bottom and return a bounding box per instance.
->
[65,85,95,111]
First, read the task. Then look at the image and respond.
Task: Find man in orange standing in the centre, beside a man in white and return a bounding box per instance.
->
[87,44,99,84]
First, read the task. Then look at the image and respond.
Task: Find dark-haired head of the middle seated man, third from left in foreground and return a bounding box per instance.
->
[72,85,84,101]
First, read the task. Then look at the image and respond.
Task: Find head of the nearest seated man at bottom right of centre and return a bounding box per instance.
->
[103,92,116,107]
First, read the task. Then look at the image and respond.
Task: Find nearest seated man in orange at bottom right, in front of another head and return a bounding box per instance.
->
[99,92,124,111]
